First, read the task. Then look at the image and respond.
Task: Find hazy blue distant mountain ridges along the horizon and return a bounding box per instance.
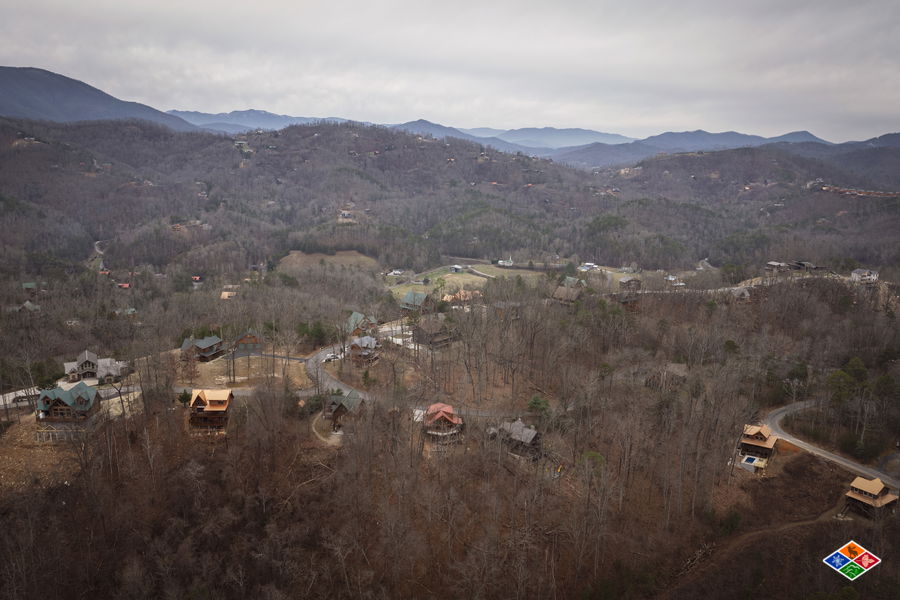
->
[0,67,896,168]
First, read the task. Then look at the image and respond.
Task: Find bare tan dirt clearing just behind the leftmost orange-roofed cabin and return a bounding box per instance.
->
[173,350,312,388]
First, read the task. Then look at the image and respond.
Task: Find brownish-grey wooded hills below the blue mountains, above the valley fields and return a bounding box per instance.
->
[0,120,898,280]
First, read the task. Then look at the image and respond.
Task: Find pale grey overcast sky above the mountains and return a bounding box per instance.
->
[0,0,900,141]
